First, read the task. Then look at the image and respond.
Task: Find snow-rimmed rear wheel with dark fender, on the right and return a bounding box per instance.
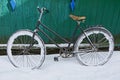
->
[74,27,114,66]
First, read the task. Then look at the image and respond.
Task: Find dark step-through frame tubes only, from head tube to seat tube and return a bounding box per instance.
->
[34,21,80,48]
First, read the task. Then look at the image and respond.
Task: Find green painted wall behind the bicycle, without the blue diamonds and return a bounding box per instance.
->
[0,0,120,43]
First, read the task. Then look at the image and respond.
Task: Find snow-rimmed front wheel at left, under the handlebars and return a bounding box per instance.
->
[7,30,46,69]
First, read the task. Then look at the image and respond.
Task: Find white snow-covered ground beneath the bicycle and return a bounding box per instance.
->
[0,51,120,80]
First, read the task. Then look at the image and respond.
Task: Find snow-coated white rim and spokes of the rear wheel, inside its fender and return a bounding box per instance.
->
[76,31,113,66]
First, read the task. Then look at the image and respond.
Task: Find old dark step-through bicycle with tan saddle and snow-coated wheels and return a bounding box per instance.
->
[7,7,114,69]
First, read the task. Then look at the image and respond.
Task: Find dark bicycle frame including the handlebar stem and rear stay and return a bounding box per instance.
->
[30,8,96,53]
